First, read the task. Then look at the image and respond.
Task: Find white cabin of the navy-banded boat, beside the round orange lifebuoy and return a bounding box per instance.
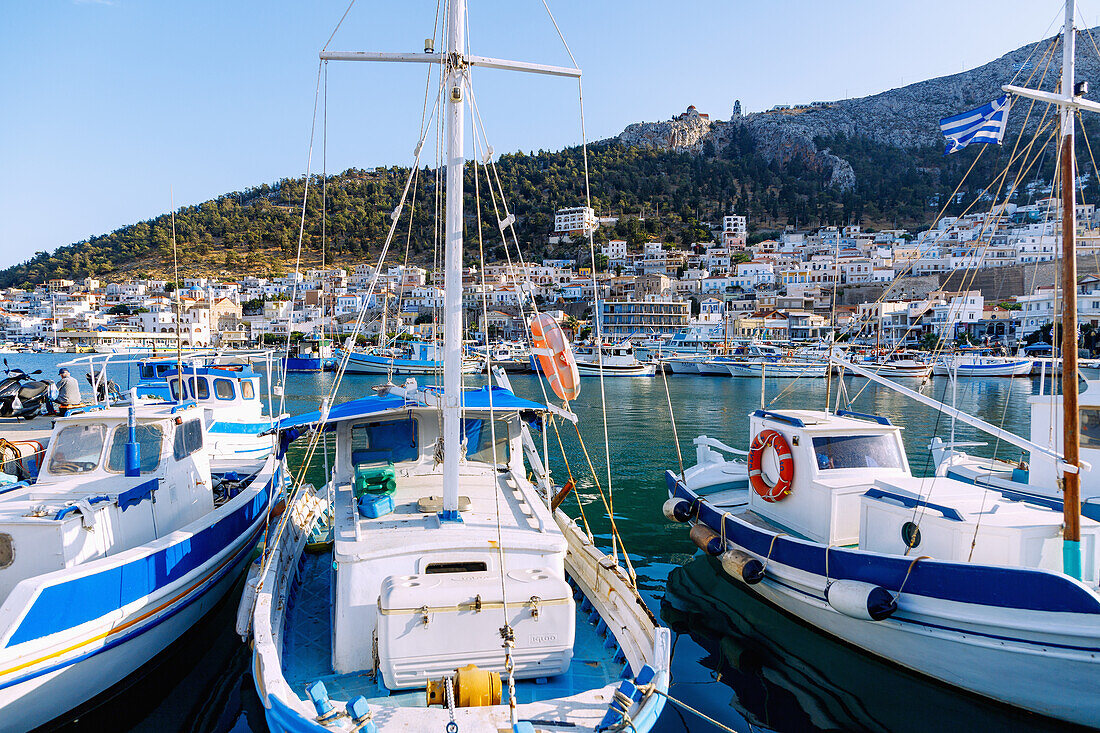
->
[749,409,1100,586]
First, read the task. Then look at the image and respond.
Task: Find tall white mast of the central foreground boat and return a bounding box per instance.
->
[441,0,466,522]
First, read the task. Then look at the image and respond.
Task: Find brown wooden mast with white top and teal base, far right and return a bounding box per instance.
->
[1059,0,1081,578]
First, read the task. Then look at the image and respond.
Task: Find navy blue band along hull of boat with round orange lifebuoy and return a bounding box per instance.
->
[666,471,1100,614]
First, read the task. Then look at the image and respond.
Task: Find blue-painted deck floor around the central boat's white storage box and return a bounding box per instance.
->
[283,551,626,707]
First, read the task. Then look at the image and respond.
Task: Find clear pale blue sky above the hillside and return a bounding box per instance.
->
[0,0,1082,266]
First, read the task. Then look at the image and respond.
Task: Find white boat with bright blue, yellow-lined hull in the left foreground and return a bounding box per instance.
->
[0,401,281,731]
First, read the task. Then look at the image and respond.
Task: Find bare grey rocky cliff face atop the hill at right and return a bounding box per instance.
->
[618,28,1100,190]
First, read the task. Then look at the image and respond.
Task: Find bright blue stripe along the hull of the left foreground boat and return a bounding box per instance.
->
[6,482,271,647]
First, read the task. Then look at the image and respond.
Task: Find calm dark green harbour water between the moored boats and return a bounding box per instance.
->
[15,354,1054,733]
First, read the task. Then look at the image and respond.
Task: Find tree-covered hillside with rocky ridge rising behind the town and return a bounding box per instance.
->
[0,23,1100,287]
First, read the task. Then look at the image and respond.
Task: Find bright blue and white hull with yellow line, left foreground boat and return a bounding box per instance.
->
[0,464,272,733]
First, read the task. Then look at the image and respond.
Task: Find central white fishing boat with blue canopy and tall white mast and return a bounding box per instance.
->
[238,0,671,733]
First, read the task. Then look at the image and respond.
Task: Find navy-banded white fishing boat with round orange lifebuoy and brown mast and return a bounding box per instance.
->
[664,9,1100,726]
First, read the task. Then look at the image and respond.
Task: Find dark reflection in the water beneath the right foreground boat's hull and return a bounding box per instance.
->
[661,554,1084,733]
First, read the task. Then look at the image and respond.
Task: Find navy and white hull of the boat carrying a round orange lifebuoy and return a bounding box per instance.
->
[667,472,1100,725]
